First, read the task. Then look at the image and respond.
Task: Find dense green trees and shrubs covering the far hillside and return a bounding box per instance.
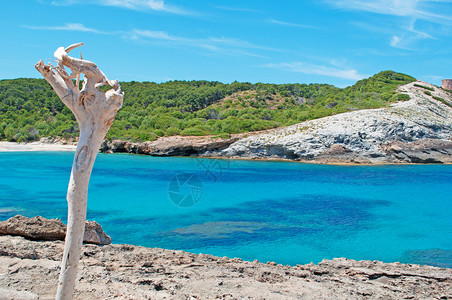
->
[0,71,415,142]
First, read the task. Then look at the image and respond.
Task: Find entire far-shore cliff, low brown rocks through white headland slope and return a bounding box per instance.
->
[101,81,452,164]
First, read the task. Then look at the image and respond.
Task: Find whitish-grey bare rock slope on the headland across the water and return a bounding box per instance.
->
[220,81,452,163]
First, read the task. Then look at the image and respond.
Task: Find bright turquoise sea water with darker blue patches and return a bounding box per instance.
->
[0,152,452,267]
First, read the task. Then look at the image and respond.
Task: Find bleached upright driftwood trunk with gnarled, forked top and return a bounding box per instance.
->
[35,43,124,299]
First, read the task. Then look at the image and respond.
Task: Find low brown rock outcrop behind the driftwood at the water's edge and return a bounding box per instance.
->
[0,215,111,245]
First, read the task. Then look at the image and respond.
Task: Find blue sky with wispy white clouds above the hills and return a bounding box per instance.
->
[0,0,452,87]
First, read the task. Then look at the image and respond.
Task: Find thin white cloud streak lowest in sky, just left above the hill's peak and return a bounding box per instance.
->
[264,62,367,80]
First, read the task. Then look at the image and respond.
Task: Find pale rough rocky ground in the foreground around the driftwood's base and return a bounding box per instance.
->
[0,235,452,300]
